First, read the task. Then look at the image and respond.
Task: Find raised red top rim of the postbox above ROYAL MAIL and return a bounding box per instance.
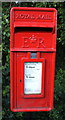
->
[11,7,57,12]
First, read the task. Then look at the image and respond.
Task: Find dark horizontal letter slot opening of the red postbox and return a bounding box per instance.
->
[15,27,53,32]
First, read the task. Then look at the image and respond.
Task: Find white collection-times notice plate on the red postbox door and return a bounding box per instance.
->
[24,62,42,94]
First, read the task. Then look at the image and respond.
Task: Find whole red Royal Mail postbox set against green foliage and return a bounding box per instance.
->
[10,7,56,112]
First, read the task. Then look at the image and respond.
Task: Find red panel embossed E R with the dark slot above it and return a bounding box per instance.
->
[14,27,53,48]
